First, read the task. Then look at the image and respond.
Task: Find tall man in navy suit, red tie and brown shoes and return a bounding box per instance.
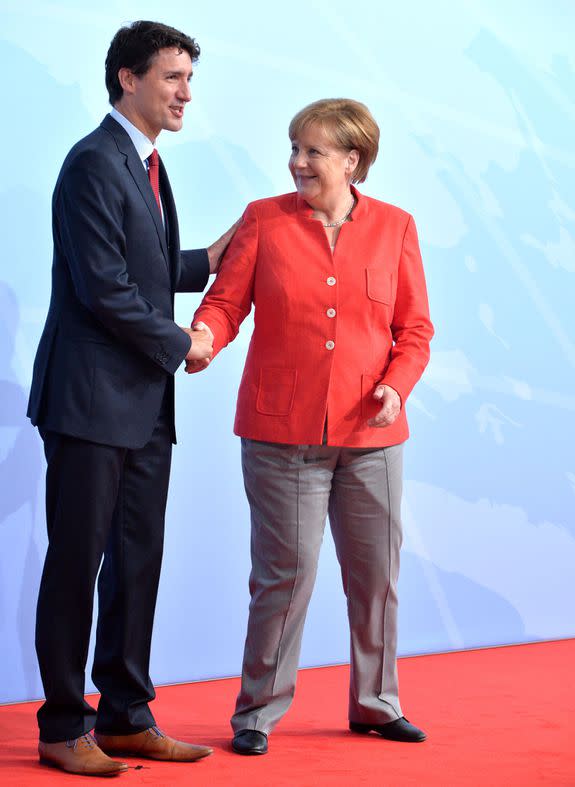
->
[28,22,234,775]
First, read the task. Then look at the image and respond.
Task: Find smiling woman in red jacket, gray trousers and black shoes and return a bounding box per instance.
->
[188,99,433,754]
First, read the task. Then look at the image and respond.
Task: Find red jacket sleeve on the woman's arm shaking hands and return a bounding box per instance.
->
[194,205,258,357]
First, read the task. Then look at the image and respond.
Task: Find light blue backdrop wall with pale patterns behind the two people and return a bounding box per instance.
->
[0,0,575,701]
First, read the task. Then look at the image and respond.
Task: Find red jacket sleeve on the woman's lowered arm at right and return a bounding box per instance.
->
[380,216,433,404]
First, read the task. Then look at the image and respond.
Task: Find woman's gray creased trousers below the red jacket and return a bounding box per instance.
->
[231,439,403,733]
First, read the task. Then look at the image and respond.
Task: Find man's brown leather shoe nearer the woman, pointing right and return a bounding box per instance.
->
[95,727,213,762]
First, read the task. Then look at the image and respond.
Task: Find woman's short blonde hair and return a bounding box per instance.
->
[289,98,379,183]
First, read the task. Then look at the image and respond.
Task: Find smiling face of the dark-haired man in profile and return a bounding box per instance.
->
[122,47,192,142]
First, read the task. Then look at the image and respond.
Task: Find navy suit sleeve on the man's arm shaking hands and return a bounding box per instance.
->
[59,151,194,374]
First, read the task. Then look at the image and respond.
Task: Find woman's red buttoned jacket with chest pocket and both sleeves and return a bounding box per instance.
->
[194,189,433,447]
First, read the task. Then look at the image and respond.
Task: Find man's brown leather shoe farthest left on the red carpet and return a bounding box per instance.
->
[38,732,128,776]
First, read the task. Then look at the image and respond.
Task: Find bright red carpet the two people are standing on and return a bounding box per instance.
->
[0,640,575,787]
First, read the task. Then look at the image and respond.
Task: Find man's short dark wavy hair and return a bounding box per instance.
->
[106,21,200,106]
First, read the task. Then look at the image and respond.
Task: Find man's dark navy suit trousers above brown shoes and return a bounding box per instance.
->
[36,396,172,743]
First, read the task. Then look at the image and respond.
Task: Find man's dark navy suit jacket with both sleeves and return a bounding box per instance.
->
[28,115,209,448]
